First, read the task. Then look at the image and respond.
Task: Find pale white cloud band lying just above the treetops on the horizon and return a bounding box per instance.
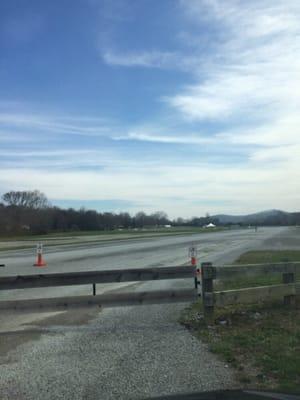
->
[0,160,300,216]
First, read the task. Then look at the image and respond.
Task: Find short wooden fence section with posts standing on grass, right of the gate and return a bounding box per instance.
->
[201,262,300,316]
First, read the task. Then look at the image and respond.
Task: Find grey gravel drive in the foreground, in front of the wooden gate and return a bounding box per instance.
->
[0,304,237,400]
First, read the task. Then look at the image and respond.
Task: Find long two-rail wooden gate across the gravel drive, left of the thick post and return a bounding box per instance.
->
[0,265,197,309]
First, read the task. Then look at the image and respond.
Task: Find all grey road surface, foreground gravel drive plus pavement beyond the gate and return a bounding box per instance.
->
[0,228,290,400]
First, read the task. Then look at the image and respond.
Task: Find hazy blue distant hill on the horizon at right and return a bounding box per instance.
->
[212,210,290,224]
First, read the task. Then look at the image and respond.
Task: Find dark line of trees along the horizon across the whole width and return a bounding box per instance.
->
[0,190,300,236]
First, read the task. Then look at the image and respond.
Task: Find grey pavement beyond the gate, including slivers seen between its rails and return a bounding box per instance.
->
[0,228,286,300]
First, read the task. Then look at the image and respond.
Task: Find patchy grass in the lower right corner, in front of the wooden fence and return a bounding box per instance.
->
[180,304,300,393]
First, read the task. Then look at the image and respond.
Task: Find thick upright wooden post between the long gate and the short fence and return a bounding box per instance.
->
[201,262,216,318]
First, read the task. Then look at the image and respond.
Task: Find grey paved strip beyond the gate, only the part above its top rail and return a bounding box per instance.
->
[0,228,286,276]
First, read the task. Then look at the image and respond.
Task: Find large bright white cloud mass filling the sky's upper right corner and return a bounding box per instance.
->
[167,0,300,121]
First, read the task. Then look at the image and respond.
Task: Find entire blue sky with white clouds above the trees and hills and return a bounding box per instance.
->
[0,0,300,217]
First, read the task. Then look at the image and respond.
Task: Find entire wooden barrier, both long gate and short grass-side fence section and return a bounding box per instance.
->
[0,262,300,315]
